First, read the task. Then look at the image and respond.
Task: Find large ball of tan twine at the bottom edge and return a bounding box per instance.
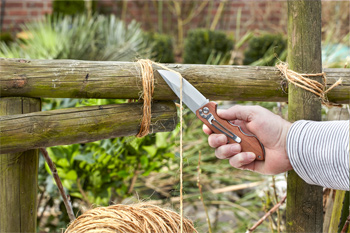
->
[65,203,198,233]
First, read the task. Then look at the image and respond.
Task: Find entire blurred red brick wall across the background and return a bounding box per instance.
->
[0,0,350,41]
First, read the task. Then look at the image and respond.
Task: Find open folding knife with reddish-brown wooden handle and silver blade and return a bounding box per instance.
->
[158,70,265,160]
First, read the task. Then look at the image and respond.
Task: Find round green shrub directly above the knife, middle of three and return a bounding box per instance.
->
[184,29,234,64]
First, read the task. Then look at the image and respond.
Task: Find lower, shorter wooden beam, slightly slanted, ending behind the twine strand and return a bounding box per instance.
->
[0,101,177,154]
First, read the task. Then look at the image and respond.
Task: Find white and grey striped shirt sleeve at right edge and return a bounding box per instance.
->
[287,120,350,190]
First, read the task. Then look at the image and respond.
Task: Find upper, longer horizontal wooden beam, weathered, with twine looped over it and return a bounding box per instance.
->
[0,58,350,103]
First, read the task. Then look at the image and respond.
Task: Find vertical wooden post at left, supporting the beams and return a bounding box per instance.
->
[0,97,41,232]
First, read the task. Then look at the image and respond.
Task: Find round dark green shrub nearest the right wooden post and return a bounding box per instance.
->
[243,34,287,66]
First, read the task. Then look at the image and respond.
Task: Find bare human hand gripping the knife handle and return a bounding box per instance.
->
[203,105,293,175]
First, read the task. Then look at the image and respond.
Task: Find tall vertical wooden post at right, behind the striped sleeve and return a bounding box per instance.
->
[287,0,323,232]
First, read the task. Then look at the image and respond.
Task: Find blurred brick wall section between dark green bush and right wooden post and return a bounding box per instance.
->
[94,0,287,34]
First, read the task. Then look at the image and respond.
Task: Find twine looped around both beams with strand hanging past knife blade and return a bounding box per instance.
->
[136,59,184,233]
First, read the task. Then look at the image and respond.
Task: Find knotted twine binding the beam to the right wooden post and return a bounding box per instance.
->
[276,62,343,106]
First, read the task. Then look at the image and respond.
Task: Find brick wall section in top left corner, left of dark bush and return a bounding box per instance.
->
[0,0,52,31]
